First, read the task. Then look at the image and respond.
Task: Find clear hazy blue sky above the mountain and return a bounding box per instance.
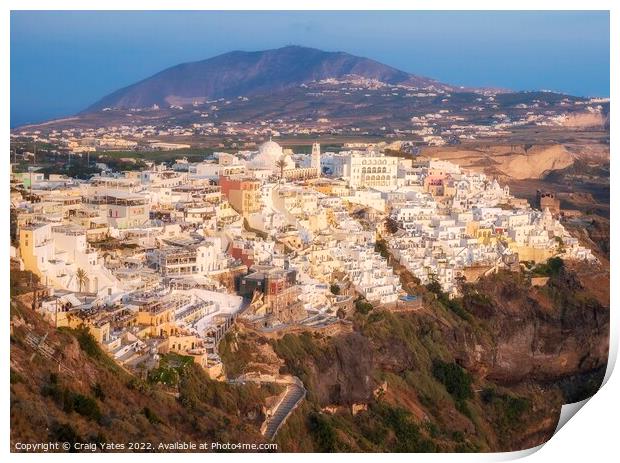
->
[10,11,609,127]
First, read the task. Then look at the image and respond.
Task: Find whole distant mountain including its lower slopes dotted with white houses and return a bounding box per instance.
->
[18,46,609,133]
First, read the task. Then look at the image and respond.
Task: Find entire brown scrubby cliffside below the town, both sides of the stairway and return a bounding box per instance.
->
[11,265,609,452]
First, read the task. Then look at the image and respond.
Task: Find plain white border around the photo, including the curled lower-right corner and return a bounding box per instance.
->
[0,0,620,463]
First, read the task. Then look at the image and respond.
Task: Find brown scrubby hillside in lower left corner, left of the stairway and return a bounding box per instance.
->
[11,278,277,451]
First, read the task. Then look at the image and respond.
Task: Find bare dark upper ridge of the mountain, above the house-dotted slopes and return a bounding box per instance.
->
[84,46,452,113]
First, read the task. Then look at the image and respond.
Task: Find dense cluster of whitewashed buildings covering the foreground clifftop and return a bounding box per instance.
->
[11,140,595,378]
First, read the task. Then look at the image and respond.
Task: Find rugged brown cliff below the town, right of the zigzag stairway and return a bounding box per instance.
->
[220,267,609,451]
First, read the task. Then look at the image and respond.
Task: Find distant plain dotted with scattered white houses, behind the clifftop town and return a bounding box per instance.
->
[11,81,609,154]
